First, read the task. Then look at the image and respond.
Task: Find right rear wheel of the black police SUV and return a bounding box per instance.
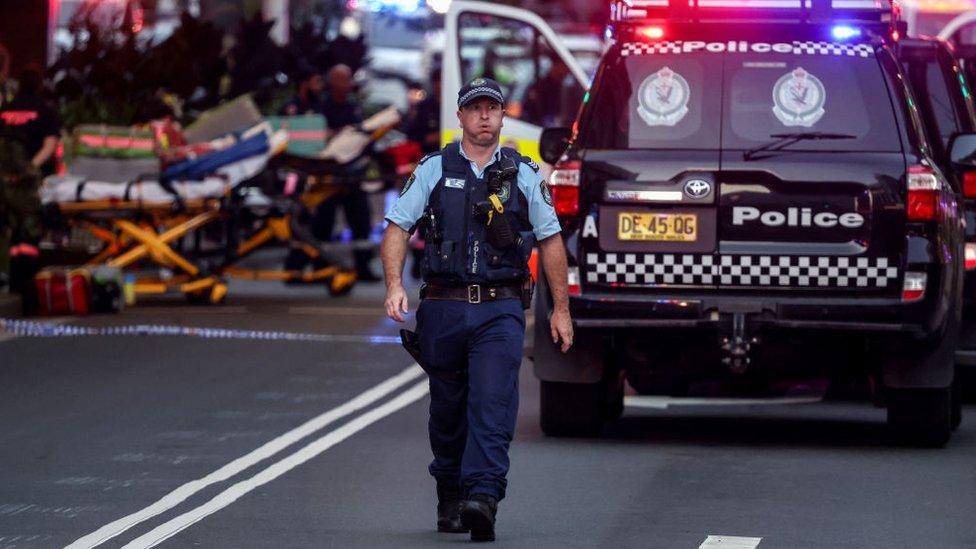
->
[887,388,952,448]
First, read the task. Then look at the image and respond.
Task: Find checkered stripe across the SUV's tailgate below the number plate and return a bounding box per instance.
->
[584,253,898,288]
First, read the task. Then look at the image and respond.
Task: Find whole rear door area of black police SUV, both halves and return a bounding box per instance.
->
[579,0,915,296]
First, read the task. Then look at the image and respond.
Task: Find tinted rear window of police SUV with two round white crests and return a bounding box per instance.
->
[581,43,901,152]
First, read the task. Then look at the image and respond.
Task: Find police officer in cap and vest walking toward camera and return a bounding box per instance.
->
[382,78,573,541]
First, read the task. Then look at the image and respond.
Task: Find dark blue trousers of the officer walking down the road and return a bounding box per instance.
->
[417,299,525,500]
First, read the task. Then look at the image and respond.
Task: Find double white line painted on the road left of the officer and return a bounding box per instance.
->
[68,364,428,549]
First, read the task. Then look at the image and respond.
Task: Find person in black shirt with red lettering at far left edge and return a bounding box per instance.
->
[0,66,61,308]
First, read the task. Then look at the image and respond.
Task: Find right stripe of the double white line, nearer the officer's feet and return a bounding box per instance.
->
[123,380,428,549]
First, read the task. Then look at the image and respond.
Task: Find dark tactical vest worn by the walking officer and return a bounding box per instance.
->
[423,143,535,286]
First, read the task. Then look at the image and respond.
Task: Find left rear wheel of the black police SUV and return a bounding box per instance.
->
[539,381,604,437]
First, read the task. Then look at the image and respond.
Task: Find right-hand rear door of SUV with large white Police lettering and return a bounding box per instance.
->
[718,41,906,293]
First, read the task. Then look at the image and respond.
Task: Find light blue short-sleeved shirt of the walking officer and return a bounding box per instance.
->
[386,145,561,240]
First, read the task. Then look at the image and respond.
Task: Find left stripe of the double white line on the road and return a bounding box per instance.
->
[68,364,426,549]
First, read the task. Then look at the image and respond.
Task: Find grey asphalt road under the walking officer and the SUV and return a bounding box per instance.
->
[0,283,976,549]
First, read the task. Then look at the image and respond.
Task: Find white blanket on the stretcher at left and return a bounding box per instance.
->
[40,132,283,204]
